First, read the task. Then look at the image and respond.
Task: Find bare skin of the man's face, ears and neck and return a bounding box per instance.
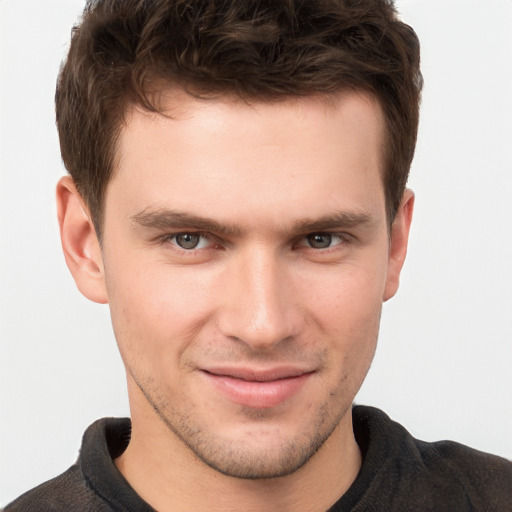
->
[57,91,414,511]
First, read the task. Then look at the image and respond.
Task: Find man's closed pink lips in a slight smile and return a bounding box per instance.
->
[202,367,313,409]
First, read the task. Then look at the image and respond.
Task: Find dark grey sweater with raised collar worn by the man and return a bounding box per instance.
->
[5,406,512,512]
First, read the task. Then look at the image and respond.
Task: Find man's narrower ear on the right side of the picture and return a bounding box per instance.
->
[383,189,414,301]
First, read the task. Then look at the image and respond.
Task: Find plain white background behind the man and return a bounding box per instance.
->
[0,0,512,505]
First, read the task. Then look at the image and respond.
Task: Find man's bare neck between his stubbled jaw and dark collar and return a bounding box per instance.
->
[115,384,361,512]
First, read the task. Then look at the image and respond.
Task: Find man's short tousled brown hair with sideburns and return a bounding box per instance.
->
[56,0,422,232]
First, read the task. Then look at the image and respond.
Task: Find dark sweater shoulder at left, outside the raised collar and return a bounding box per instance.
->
[4,464,111,512]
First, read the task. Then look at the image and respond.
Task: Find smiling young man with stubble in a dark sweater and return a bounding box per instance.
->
[6,0,512,511]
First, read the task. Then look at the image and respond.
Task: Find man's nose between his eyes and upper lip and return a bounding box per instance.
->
[218,247,303,351]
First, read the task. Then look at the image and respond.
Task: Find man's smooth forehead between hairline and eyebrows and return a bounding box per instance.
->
[109,91,384,230]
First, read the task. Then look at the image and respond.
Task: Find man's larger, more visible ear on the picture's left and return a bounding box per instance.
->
[57,176,108,304]
